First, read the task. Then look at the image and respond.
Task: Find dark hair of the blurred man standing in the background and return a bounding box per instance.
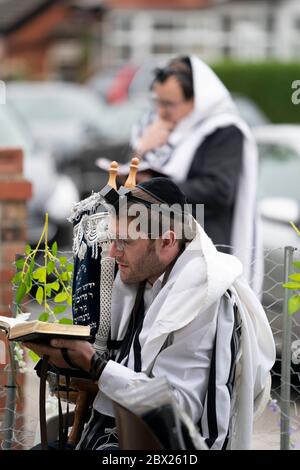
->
[151,56,194,100]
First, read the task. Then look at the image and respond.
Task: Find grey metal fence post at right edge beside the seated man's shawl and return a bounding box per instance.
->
[280,246,295,450]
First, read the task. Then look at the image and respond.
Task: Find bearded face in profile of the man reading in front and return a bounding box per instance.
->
[110,217,165,284]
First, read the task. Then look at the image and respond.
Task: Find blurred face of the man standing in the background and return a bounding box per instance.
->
[153,76,194,125]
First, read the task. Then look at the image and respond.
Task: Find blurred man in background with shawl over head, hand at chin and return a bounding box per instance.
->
[132,56,263,292]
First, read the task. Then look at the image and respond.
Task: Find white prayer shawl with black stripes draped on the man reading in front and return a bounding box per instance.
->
[94,224,275,449]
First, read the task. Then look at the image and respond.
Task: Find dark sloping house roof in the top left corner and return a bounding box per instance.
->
[0,0,62,35]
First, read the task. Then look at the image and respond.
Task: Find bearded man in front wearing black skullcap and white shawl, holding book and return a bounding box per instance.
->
[28,178,275,450]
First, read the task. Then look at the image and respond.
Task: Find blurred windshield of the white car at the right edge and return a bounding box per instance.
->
[258,143,300,203]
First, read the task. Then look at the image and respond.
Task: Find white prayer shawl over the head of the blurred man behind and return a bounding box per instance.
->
[132,56,263,293]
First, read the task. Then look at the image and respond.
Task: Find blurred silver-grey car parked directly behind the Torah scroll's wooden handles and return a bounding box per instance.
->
[7,82,150,198]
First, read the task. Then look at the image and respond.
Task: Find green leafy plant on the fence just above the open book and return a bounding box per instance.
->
[12,214,73,359]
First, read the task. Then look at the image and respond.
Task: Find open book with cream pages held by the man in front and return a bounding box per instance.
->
[0,315,91,343]
